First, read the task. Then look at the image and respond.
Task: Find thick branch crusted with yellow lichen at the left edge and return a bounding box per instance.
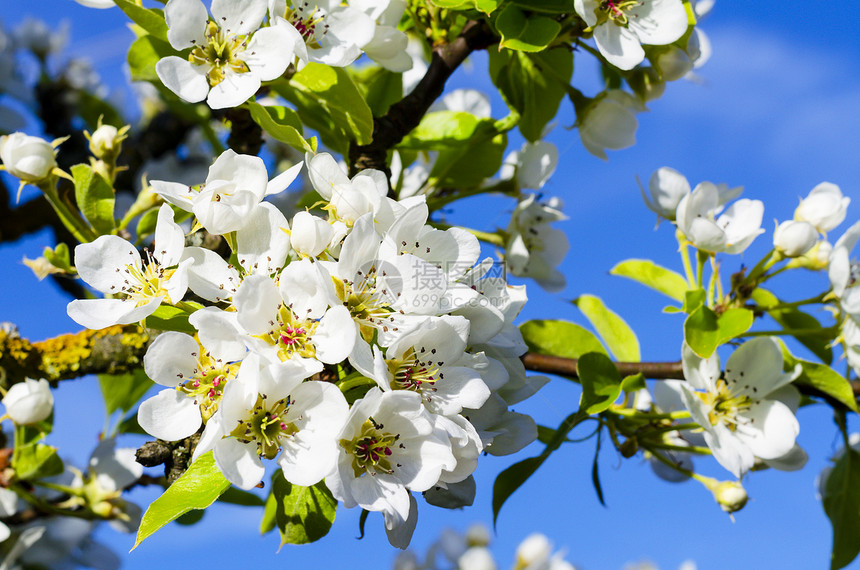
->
[0,325,154,388]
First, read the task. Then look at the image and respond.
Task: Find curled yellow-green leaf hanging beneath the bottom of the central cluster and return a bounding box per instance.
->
[266,471,337,546]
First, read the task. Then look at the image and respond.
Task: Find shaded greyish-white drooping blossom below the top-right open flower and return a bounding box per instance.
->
[577,89,646,160]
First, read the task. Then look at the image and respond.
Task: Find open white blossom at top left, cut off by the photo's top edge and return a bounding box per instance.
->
[155,0,295,109]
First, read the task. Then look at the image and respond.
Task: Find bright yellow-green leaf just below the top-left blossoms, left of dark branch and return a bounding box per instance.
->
[281,62,373,154]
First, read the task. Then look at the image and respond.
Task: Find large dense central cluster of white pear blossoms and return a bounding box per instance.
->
[68,151,546,547]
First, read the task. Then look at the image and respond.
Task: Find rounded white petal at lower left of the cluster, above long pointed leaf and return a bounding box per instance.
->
[137,389,203,441]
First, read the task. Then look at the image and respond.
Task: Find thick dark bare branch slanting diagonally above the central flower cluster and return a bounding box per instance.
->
[349,20,499,175]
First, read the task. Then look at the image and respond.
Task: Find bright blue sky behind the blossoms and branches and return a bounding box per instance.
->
[0,0,860,570]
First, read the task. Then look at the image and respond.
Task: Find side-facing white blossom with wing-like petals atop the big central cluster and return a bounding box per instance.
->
[152,149,302,234]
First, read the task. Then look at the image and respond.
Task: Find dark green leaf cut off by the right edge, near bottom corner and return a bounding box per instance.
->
[821,447,860,570]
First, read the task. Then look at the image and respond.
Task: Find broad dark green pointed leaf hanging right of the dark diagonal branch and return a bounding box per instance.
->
[490,49,573,142]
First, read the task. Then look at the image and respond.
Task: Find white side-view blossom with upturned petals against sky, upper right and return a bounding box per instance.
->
[675,182,764,254]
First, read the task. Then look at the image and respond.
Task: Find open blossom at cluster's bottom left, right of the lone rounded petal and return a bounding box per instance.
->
[201,354,349,489]
